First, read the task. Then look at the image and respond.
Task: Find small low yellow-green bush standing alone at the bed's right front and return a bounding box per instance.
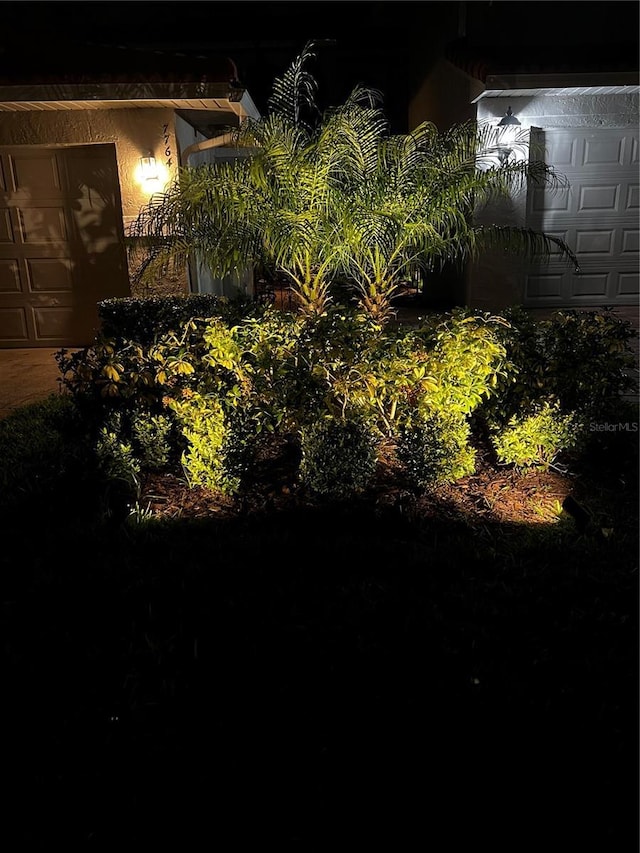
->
[491,401,583,468]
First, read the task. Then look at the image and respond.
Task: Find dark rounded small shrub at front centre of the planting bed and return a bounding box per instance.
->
[299,417,377,499]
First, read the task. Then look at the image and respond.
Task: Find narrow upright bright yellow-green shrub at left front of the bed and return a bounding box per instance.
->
[167,393,240,494]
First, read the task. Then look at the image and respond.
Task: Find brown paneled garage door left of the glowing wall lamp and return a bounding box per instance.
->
[0,145,129,348]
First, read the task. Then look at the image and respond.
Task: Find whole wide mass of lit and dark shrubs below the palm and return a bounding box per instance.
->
[48,304,632,494]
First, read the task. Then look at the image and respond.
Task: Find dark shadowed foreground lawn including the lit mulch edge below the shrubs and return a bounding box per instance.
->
[0,392,638,853]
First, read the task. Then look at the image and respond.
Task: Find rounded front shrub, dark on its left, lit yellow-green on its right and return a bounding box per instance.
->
[396,412,475,489]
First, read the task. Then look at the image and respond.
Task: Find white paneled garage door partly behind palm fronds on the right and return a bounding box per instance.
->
[525,128,640,308]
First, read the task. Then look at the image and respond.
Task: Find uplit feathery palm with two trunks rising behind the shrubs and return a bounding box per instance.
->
[129,42,577,322]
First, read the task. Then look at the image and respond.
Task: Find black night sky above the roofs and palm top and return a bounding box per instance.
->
[0,0,640,132]
